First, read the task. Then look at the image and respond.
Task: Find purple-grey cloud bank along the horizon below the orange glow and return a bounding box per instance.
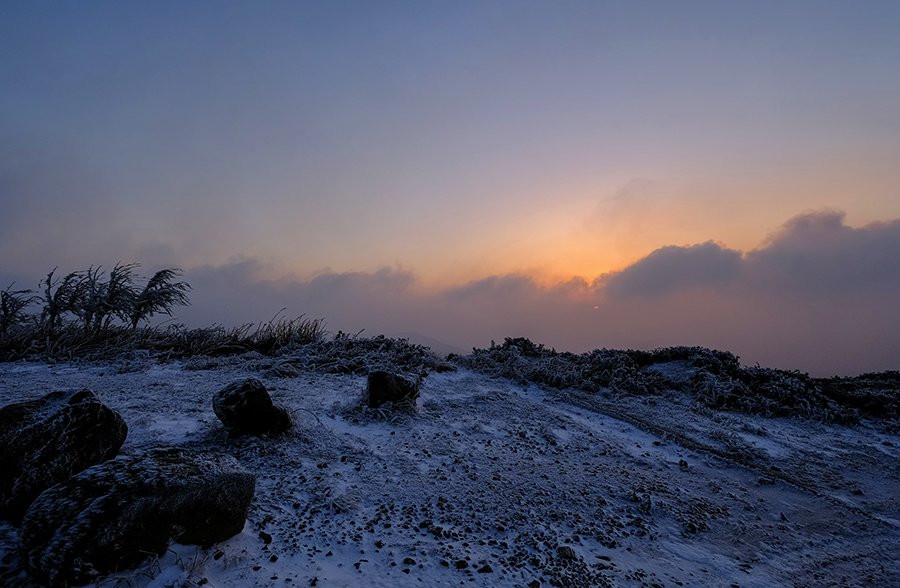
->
[165,211,900,375]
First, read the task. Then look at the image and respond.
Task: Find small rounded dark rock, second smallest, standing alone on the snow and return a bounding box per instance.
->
[213,378,293,435]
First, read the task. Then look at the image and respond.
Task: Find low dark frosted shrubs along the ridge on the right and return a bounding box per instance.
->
[455,338,900,423]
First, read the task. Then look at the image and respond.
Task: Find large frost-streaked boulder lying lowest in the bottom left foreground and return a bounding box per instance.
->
[19,449,256,586]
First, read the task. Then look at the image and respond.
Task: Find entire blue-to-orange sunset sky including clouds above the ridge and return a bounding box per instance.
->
[0,0,900,375]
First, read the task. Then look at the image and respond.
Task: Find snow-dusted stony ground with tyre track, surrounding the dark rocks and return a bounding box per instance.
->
[0,356,900,586]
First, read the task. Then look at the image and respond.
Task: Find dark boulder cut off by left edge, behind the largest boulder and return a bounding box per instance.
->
[0,389,128,523]
